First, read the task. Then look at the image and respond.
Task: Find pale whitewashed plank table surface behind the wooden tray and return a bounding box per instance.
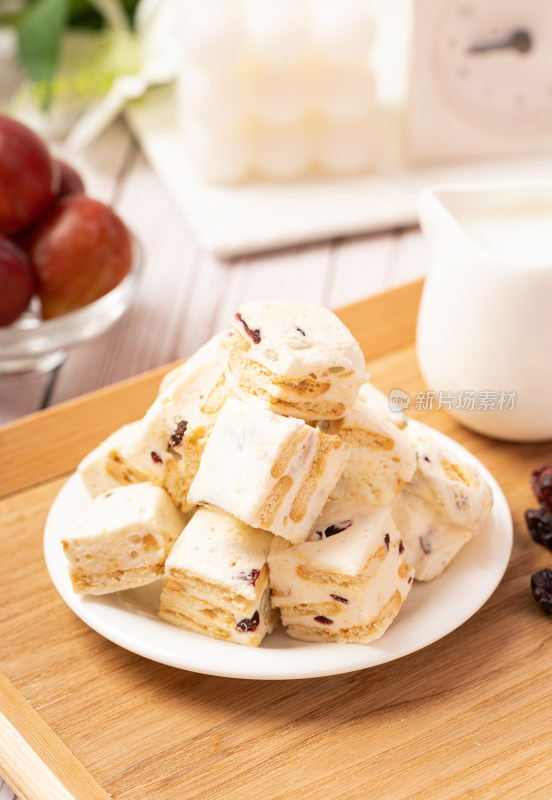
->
[0,100,427,800]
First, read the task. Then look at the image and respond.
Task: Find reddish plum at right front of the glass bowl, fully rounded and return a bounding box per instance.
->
[29,194,132,319]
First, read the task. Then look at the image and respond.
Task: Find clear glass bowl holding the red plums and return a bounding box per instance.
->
[0,237,143,374]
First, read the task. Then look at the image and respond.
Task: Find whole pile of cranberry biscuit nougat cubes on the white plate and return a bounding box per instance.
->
[63,302,492,645]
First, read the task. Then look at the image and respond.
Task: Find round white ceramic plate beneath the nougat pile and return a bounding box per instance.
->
[44,424,513,679]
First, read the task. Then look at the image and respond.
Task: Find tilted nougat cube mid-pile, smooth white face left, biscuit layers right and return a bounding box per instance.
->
[188,398,350,543]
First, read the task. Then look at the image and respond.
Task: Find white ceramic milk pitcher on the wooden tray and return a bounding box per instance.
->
[417,181,552,441]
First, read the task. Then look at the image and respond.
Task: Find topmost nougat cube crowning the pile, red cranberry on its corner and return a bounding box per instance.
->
[224,302,366,421]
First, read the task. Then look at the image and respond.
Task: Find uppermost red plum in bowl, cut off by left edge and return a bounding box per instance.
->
[0,115,59,233]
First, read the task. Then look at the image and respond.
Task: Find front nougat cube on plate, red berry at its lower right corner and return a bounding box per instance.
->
[159,508,277,646]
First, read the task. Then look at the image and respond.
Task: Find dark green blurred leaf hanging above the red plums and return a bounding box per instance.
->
[17,0,69,92]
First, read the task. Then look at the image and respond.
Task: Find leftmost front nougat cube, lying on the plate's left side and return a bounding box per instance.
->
[62,483,186,594]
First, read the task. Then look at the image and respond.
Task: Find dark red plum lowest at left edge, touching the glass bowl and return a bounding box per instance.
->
[0,234,36,325]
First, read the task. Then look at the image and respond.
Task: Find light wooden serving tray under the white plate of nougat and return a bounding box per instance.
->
[0,283,552,800]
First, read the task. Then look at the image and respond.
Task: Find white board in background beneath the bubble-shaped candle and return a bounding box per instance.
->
[126,86,552,257]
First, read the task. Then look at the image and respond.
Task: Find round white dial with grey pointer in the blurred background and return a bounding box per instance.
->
[433,0,552,135]
